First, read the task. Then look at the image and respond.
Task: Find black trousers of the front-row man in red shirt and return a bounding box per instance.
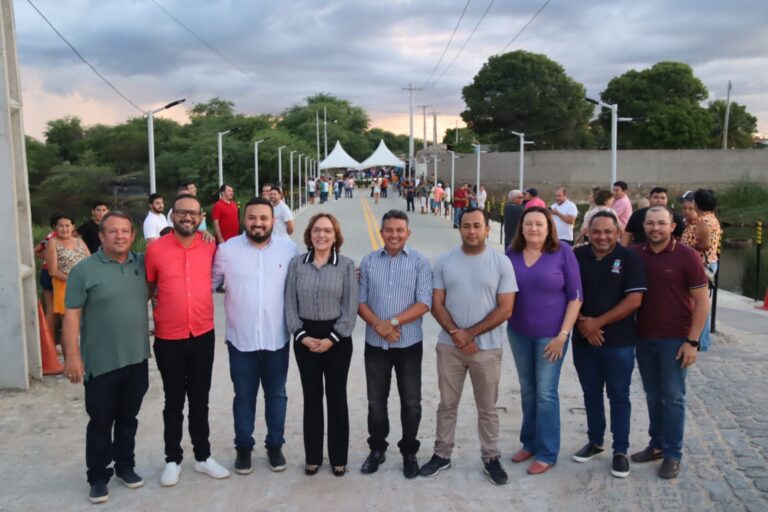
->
[154,330,216,464]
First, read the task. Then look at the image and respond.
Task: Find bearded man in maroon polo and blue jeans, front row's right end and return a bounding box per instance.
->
[632,206,709,478]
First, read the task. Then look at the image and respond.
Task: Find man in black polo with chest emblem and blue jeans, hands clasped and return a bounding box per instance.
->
[573,211,647,478]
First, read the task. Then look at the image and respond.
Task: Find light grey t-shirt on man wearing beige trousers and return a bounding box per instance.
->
[432,246,517,350]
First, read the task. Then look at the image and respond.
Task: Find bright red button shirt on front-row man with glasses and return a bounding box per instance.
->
[144,233,216,340]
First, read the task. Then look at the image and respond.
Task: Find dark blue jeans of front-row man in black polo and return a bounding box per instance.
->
[573,343,635,454]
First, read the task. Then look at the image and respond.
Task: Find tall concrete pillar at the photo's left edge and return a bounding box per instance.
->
[0,0,42,389]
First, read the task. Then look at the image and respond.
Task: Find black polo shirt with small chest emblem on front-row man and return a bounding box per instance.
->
[573,244,648,347]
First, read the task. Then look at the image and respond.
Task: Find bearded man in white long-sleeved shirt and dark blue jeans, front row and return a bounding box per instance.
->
[213,197,299,474]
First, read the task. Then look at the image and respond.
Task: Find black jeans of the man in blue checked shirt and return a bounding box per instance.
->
[365,342,423,455]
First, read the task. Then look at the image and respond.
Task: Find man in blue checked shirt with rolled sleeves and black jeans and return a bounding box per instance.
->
[358,210,432,478]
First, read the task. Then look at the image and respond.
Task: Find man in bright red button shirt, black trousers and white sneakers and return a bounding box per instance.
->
[145,194,231,487]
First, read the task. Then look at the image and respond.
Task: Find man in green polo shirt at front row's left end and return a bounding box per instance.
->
[62,211,149,503]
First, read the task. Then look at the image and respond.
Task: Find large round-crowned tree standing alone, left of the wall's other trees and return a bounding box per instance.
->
[461,50,591,150]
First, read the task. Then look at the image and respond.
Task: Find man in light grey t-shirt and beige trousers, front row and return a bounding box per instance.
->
[419,208,518,485]
